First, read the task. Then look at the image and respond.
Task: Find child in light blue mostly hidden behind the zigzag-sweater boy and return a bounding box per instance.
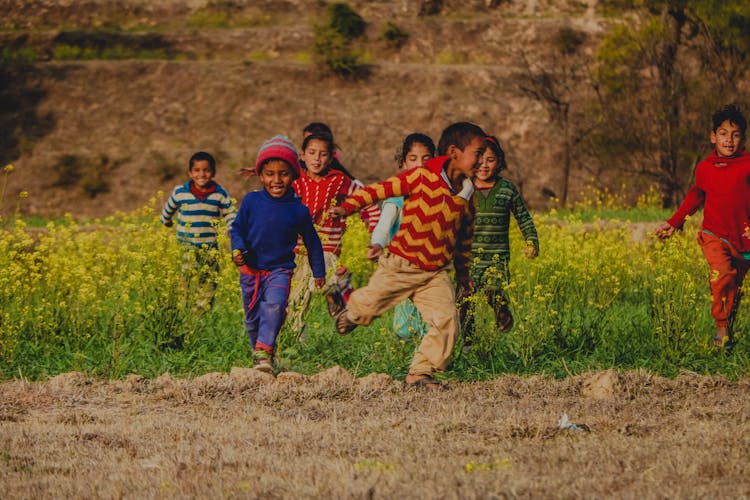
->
[367,133,435,339]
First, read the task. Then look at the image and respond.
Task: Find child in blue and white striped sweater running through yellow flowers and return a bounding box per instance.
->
[160,151,236,312]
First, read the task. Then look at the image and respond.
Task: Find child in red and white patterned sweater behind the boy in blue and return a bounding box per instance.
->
[289,132,354,332]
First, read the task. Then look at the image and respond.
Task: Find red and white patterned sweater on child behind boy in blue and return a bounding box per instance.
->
[292,169,354,255]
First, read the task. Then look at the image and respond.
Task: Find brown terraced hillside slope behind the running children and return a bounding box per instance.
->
[0,0,607,216]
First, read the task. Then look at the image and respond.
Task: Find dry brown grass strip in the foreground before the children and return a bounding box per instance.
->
[0,368,750,498]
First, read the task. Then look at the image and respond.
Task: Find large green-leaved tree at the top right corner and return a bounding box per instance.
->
[585,0,750,206]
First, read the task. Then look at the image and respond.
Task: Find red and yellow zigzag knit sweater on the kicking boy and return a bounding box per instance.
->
[341,156,475,279]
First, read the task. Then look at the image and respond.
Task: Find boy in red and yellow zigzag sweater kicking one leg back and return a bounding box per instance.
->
[329,122,486,390]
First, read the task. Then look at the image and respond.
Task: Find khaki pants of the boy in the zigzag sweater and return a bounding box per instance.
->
[347,254,458,375]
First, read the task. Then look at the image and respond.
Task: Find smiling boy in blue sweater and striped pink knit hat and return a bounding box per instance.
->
[229,135,326,373]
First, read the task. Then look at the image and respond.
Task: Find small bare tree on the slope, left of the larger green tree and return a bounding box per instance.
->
[519,27,594,206]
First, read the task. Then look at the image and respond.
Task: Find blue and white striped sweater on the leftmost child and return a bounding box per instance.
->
[161,180,237,246]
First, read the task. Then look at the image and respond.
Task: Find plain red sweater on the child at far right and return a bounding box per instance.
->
[667,147,750,252]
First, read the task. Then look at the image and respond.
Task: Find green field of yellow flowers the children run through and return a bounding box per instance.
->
[0,193,750,380]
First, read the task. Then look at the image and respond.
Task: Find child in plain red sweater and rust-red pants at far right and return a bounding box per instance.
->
[656,104,750,351]
